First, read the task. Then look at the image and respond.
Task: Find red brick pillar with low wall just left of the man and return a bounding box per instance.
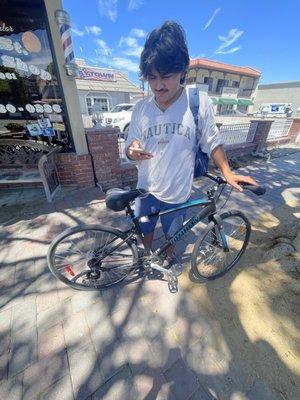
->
[86,128,137,190]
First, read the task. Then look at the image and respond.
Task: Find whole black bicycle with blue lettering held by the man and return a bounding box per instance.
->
[47,174,265,290]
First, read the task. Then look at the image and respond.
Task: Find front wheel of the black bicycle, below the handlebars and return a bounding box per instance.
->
[191,211,251,279]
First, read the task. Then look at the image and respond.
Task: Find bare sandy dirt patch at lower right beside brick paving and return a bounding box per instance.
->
[183,200,300,400]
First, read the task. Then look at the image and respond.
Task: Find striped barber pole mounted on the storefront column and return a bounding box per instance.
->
[55,10,78,77]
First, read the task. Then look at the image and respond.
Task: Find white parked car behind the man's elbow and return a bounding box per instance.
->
[101,103,134,139]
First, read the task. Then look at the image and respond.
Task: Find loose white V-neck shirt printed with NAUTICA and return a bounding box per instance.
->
[126,90,222,203]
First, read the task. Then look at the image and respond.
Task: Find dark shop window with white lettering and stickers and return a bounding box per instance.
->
[0,0,72,149]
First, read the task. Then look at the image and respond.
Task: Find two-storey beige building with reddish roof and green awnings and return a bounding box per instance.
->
[187,58,261,115]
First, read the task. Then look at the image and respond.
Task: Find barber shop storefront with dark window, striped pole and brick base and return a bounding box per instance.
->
[0,0,95,194]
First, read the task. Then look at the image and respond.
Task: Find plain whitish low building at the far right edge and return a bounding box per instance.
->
[253,81,300,117]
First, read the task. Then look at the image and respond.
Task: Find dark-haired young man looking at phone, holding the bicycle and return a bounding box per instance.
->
[126,21,257,264]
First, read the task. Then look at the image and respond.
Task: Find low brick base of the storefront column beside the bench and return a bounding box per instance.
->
[55,153,95,187]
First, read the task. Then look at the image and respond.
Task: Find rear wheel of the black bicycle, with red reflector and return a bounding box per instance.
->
[47,225,138,290]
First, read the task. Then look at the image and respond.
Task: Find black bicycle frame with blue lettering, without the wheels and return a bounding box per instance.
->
[124,199,216,256]
